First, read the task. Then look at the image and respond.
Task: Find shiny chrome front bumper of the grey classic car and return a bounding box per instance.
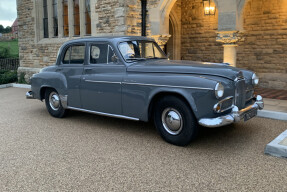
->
[198,95,264,128]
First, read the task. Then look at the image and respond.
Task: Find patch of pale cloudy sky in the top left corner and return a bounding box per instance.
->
[0,0,17,27]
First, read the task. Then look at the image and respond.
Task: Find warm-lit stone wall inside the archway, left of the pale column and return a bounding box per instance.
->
[181,0,223,62]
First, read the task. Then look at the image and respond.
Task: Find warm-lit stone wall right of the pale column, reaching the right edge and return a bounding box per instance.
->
[237,0,287,89]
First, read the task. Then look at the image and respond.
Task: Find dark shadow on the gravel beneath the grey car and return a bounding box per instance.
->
[36,108,256,150]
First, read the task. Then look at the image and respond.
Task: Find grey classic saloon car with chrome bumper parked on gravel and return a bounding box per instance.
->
[26,36,264,145]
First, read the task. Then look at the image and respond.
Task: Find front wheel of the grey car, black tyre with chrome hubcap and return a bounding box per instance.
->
[154,96,198,146]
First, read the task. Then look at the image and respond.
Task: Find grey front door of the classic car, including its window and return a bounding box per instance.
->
[81,43,126,115]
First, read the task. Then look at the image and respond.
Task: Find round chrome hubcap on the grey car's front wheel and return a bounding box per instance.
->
[161,108,183,135]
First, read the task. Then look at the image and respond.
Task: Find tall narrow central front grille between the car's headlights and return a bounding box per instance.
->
[234,79,246,109]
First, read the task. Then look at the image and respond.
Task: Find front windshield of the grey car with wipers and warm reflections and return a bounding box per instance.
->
[119,41,167,62]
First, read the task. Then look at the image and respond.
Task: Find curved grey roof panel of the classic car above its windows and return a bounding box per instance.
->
[62,36,154,44]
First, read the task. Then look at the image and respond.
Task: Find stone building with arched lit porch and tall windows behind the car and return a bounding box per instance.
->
[17,0,287,89]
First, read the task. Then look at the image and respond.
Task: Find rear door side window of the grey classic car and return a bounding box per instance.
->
[63,45,85,64]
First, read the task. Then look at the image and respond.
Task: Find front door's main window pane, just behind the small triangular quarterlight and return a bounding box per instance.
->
[90,44,109,64]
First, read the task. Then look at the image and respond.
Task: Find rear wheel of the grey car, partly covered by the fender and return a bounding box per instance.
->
[45,89,66,118]
